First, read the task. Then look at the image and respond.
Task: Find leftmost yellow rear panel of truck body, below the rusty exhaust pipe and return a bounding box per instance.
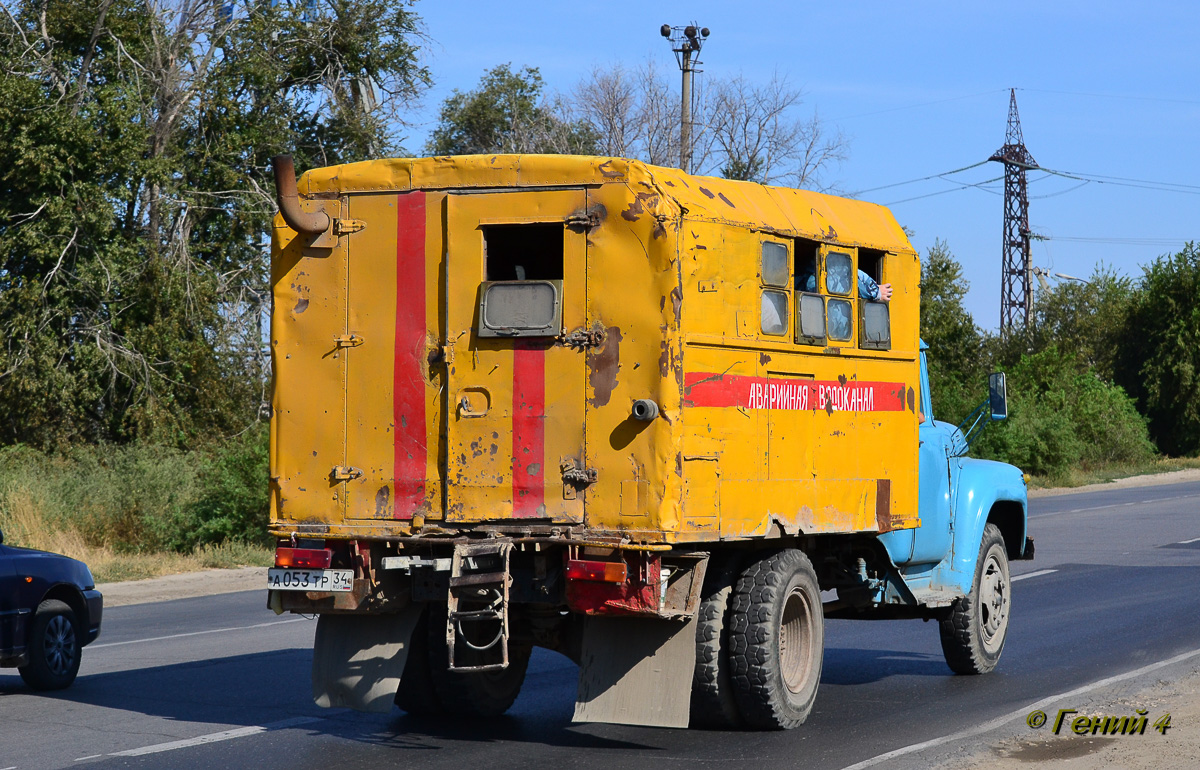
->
[270,208,347,523]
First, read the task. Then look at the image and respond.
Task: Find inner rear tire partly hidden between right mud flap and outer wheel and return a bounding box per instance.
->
[690,554,742,729]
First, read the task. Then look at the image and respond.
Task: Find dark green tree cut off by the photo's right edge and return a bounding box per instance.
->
[1116,242,1200,455]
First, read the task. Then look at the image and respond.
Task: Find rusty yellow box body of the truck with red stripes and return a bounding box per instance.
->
[271,156,920,543]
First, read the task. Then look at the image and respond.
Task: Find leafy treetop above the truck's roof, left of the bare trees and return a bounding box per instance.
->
[426,64,599,155]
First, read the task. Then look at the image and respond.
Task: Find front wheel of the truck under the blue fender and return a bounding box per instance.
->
[940,524,1013,674]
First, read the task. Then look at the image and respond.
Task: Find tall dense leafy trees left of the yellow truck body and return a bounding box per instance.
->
[0,0,428,449]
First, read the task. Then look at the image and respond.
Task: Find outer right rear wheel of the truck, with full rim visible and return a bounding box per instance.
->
[728,549,824,729]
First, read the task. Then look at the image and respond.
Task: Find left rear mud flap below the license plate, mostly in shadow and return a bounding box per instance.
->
[312,604,425,714]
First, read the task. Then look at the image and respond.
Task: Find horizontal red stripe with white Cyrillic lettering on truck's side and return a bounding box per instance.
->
[683,372,908,411]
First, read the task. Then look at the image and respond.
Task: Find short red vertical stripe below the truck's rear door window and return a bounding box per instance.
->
[512,339,546,518]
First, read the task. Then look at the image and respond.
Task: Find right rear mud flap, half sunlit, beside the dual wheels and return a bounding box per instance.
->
[574,616,696,727]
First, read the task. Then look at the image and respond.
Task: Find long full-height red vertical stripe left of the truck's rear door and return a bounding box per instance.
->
[392,192,426,519]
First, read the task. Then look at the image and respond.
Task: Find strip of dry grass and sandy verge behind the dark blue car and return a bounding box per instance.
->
[0,486,275,583]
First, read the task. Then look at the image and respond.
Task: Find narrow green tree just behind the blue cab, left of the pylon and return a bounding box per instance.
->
[920,240,988,422]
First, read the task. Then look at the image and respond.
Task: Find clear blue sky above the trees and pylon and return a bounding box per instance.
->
[406,0,1200,329]
